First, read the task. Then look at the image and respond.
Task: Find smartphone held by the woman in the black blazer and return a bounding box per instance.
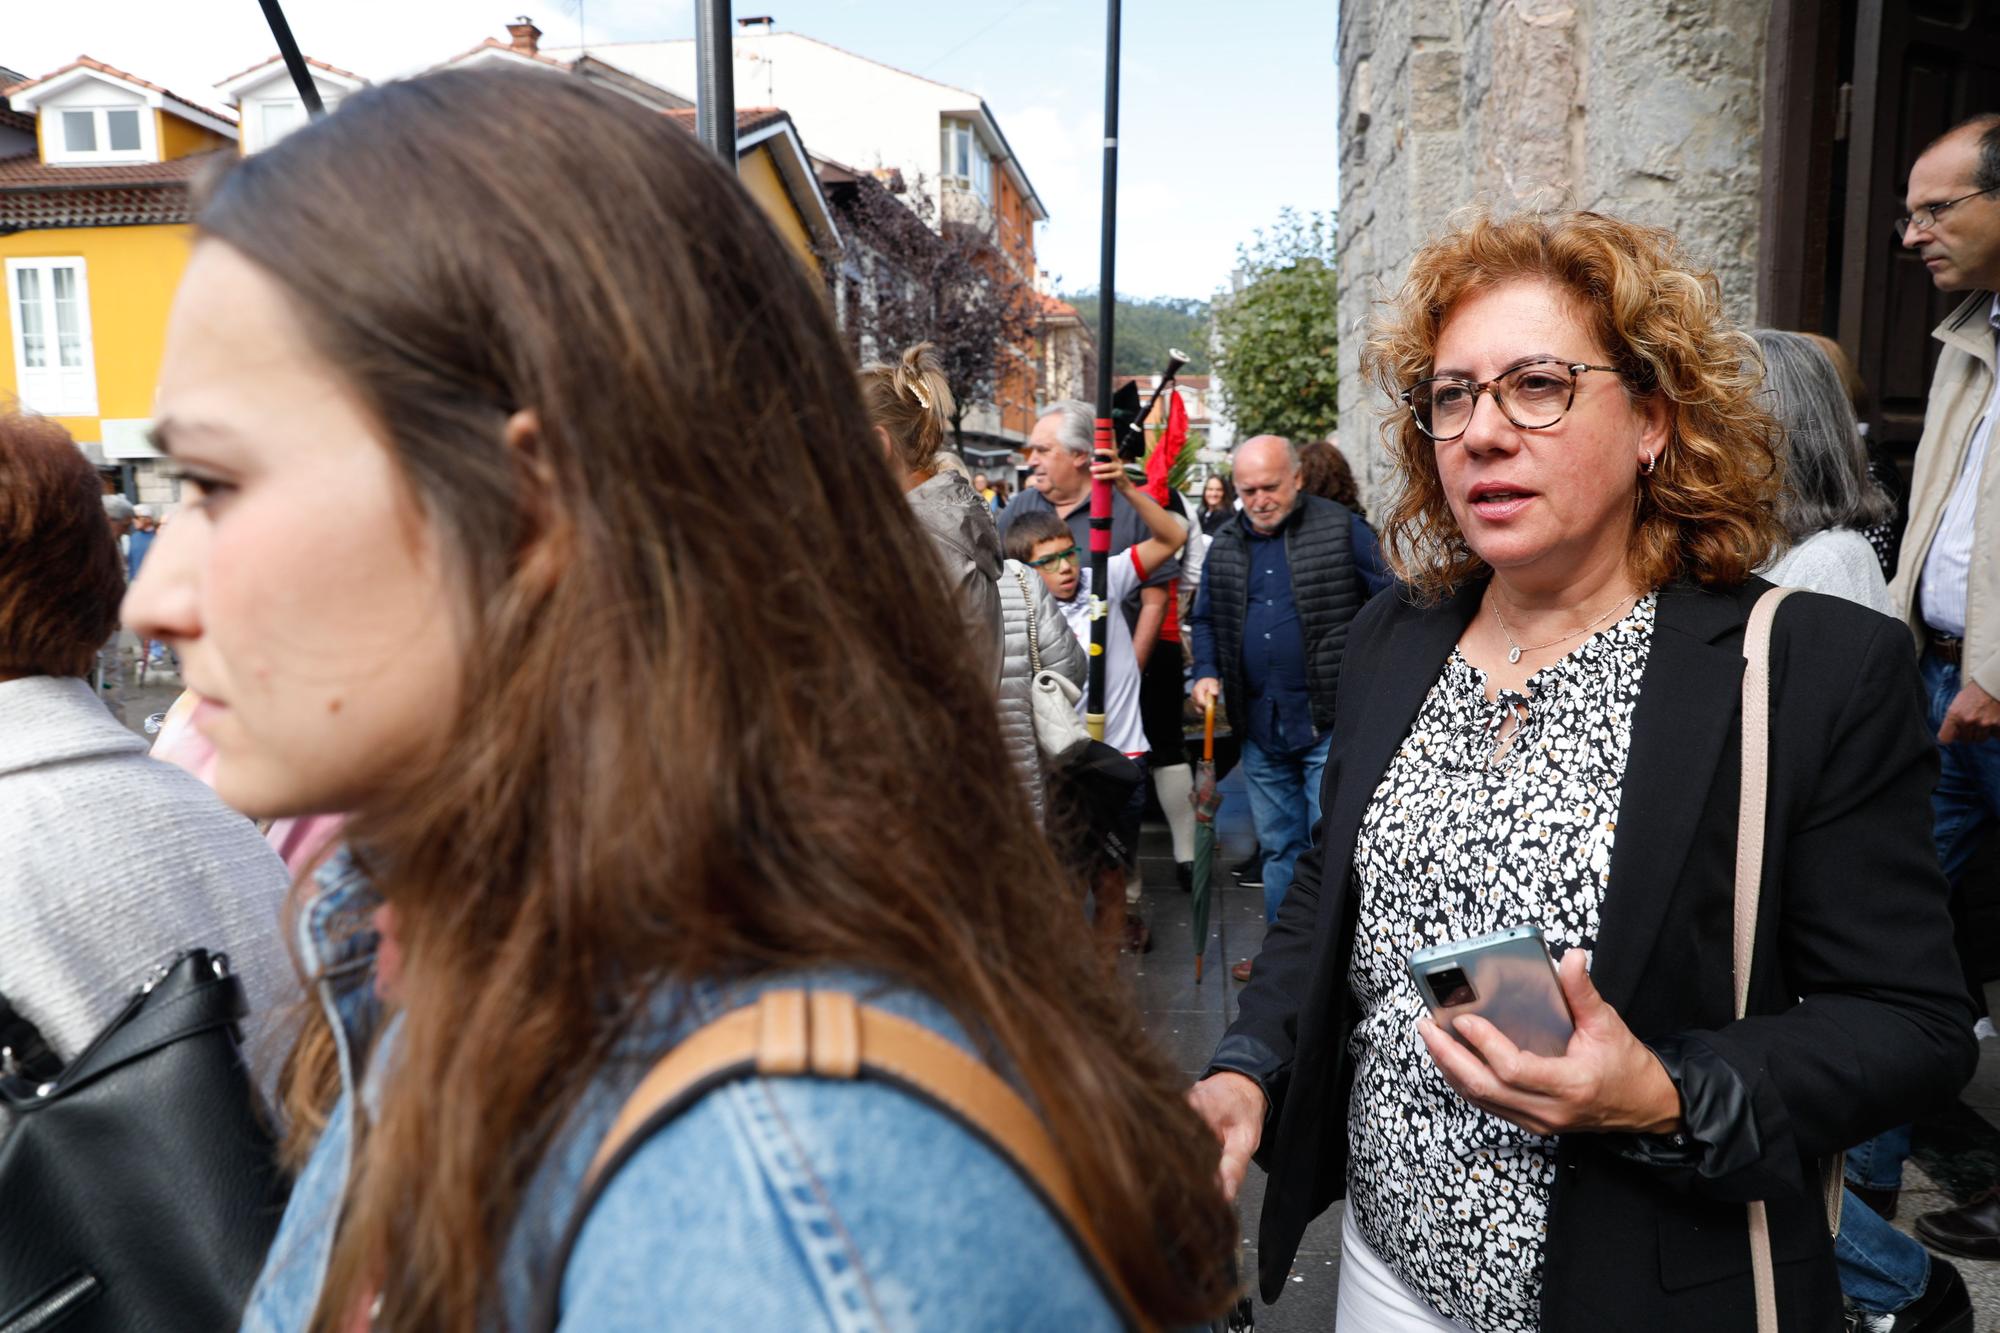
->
[1410,925,1576,1055]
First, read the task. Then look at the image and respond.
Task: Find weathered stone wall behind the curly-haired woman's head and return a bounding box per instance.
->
[1338,0,1770,498]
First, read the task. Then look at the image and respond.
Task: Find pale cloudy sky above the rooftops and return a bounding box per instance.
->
[11,0,1336,296]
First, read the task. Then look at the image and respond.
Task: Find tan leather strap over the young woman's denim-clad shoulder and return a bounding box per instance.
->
[572,989,1152,1333]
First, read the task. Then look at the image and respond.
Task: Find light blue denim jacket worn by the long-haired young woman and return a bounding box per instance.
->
[242,853,1120,1333]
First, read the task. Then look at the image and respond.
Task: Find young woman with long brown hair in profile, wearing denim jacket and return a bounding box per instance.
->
[126,72,1234,1333]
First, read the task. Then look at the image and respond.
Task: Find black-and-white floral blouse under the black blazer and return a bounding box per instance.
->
[1348,594,1658,1333]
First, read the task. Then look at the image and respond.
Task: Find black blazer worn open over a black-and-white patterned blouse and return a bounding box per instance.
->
[1212,578,1978,1333]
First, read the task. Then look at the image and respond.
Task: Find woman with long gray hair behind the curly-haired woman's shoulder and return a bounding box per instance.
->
[1752,328,1896,614]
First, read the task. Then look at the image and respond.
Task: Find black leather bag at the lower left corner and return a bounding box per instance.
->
[0,949,288,1333]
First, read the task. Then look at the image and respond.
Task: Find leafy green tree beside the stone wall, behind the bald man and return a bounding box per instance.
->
[1214,208,1340,442]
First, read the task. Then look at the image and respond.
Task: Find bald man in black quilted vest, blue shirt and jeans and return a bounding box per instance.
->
[1188,434,1390,981]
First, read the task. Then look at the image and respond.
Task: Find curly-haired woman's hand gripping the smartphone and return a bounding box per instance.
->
[1416,949,1680,1137]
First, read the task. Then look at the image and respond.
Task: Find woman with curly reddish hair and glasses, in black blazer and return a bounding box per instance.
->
[1194,212,1974,1333]
